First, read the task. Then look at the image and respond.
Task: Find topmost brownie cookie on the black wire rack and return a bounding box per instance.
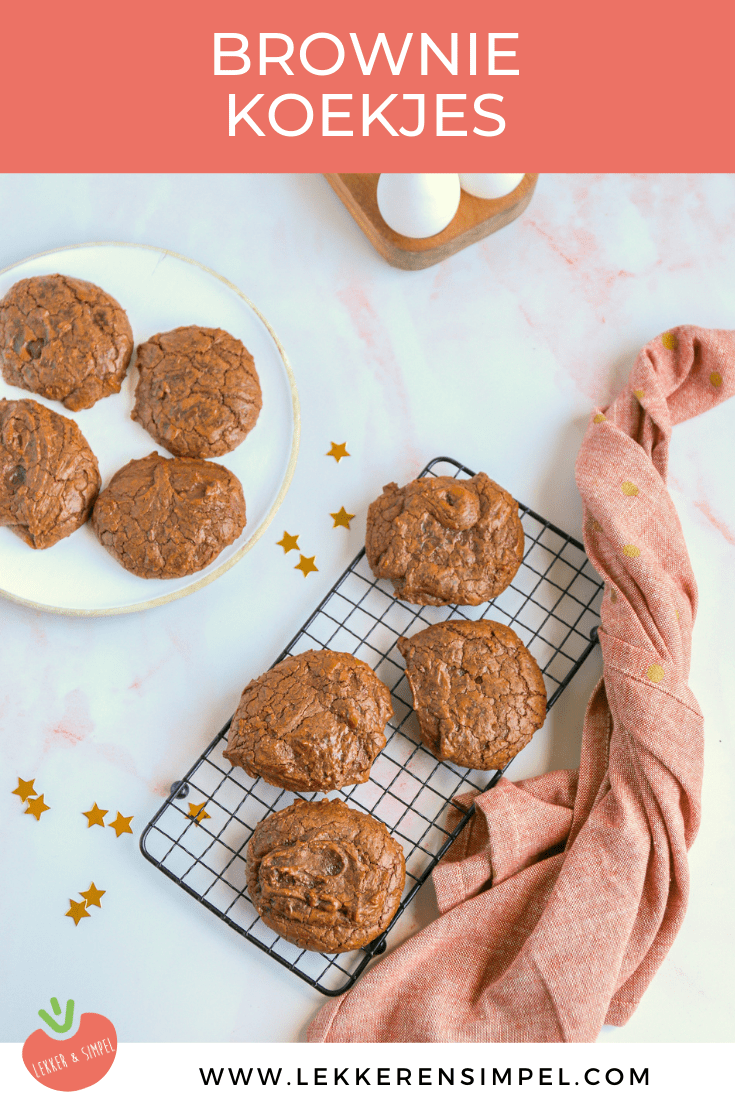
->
[365,474,523,605]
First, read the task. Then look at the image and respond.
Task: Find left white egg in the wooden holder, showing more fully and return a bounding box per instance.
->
[378,172,461,237]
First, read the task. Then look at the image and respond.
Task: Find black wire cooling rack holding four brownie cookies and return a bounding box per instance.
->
[140,456,603,995]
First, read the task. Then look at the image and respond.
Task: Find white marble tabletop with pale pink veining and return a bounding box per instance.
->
[0,175,735,1044]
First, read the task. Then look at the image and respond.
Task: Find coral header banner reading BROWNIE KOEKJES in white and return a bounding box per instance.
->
[0,0,735,172]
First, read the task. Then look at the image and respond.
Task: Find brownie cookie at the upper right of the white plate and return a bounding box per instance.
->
[131,325,262,458]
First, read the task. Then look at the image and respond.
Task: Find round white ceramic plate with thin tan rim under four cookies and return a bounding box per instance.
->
[0,242,299,616]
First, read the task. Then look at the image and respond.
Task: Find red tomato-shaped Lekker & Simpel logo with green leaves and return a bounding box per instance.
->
[23,998,118,1091]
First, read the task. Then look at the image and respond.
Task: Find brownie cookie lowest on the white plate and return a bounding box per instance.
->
[91,452,245,579]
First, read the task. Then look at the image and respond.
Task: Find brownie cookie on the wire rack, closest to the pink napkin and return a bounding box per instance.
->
[398,620,547,769]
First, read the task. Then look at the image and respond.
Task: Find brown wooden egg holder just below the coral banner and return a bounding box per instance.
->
[324,172,539,271]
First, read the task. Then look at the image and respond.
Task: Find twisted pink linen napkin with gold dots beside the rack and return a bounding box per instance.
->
[309,326,735,1041]
